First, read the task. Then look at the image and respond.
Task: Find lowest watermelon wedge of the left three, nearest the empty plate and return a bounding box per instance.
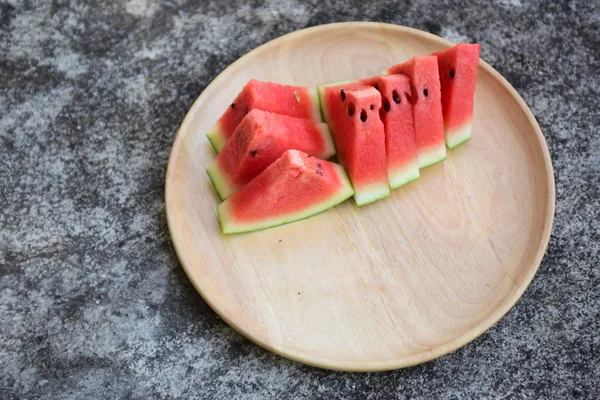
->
[217,150,354,234]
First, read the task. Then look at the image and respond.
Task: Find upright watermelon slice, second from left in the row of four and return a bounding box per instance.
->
[361,74,419,188]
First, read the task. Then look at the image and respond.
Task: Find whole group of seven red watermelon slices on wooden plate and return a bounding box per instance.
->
[207,43,481,234]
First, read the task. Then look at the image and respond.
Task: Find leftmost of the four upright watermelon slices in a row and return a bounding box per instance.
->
[318,82,390,206]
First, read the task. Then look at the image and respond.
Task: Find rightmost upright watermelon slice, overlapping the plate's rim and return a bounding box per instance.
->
[434,43,481,148]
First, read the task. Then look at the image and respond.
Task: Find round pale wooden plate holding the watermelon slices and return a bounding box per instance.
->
[166,23,555,371]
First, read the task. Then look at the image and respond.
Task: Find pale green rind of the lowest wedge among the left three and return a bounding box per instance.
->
[217,165,354,235]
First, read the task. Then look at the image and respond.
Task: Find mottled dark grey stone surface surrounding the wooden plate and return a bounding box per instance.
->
[0,0,600,399]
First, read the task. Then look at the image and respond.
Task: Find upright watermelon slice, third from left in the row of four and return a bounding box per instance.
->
[387,56,446,168]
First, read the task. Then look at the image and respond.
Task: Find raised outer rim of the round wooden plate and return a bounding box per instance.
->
[164,21,556,372]
